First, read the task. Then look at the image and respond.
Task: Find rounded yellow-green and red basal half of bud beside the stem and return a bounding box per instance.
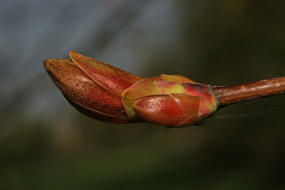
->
[122,75,217,126]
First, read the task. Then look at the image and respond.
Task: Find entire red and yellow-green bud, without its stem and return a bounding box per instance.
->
[44,51,217,127]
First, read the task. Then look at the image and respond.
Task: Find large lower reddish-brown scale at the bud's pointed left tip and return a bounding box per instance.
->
[44,53,129,123]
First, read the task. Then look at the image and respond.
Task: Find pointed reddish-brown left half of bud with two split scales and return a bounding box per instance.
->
[44,51,141,123]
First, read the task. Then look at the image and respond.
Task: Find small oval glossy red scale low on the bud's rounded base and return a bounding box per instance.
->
[133,94,200,126]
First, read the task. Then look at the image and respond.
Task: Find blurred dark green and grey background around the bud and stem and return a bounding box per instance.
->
[0,0,285,190]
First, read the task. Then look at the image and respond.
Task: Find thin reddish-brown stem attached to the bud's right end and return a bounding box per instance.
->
[212,77,285,106]
